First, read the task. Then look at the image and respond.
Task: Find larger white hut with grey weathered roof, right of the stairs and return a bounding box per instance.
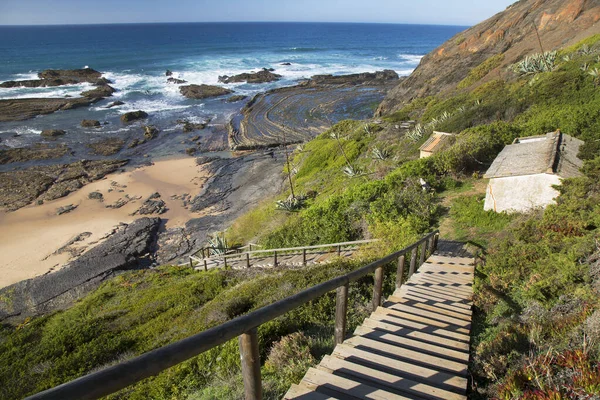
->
[484,131,583,212]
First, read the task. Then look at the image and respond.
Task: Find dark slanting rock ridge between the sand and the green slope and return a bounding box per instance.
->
[0,218,160,320]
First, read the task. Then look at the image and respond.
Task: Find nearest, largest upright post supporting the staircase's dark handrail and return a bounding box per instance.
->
[239,328,262,400]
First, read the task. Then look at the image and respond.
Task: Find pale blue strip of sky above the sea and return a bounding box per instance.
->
[0,0,515,25]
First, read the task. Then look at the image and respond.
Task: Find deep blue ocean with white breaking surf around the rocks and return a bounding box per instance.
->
[0,23,465,155]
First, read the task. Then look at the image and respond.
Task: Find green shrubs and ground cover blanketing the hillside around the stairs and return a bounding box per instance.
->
[0,35,600,399]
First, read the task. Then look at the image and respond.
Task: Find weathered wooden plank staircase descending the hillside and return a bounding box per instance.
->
[284,253,474,400]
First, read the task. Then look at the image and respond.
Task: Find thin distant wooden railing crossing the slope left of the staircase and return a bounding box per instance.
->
[189,239,377,271]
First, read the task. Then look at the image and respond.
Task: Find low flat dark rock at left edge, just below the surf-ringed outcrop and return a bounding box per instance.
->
[0,97,101,122]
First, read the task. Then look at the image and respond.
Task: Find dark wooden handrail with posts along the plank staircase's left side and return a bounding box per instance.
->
[27,231,439,400]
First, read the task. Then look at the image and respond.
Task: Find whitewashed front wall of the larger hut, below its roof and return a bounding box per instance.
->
[483,174,560,212]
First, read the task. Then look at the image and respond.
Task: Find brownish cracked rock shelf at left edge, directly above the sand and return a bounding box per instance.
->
[0,160,128,211]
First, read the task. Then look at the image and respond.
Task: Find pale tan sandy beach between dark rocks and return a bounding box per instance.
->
[0,158,209,288]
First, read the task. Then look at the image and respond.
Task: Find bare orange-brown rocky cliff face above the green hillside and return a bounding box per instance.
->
[376,0,600,116]
